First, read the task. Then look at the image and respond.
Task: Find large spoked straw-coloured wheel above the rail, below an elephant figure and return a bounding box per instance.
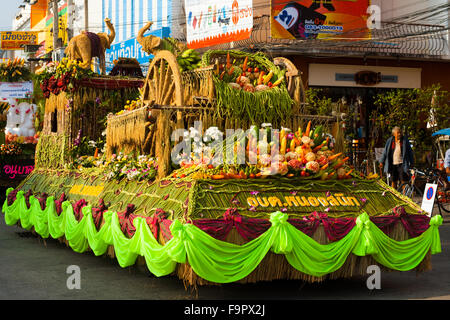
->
[142,50,183,106]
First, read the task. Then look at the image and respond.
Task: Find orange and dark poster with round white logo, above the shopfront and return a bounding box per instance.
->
[270,0,370,40]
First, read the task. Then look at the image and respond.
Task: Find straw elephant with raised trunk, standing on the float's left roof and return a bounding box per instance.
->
[65,18,116,74]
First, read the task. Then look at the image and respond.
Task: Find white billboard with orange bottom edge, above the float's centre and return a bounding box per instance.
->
[185,0,253,49]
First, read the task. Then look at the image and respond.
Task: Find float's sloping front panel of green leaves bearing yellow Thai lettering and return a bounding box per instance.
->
[184,178,420,219]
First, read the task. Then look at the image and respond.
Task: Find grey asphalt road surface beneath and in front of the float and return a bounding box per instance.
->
[0,214,450,300]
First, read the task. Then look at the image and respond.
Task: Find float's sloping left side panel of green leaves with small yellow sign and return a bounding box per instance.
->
[19,169,192,220]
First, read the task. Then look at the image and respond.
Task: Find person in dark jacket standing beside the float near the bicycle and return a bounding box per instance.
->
[380,127,414,189]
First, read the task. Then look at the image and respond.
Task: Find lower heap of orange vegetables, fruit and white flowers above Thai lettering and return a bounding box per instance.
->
[170,122,358,180]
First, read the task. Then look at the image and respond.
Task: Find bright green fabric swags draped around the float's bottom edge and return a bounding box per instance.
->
[3,188,442,283]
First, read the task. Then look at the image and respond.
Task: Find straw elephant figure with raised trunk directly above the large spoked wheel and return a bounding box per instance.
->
[136,21,187,55]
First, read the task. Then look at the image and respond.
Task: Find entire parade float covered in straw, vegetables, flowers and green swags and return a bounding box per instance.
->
[3,21,442,287]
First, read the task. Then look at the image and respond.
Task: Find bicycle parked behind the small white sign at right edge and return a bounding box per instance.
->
[397,168,450,216]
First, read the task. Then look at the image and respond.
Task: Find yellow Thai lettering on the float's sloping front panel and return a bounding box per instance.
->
[247,193,361,208]
